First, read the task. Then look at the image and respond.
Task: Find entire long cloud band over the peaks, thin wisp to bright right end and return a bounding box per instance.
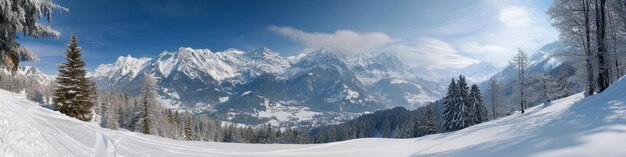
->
[268,26,478,69]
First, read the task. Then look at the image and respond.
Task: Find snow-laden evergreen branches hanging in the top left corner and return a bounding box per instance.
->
[0,0,67,73]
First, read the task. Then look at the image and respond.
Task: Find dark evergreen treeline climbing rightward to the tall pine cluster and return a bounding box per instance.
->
[311,75,493,143]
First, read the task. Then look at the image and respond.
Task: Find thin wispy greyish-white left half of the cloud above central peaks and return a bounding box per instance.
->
[267,26,392,53]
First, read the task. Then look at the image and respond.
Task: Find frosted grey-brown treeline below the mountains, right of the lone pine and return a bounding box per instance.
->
[94,87,311,144]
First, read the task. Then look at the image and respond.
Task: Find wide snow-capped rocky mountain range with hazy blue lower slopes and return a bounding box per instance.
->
[94,48,443,126]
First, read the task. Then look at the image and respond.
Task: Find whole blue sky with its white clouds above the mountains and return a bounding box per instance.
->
[20,0,558,74]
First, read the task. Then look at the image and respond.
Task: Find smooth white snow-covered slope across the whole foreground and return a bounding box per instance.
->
[0,79,626,157]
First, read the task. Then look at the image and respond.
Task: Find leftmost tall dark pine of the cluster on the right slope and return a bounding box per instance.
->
[443,78,458,131]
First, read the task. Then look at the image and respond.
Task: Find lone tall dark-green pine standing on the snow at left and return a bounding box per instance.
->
[54,36,94,121]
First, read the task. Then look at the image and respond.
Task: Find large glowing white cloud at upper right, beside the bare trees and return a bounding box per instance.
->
[454,2,558,66]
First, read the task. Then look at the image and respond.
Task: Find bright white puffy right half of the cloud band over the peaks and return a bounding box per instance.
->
[385,38,478,69]
